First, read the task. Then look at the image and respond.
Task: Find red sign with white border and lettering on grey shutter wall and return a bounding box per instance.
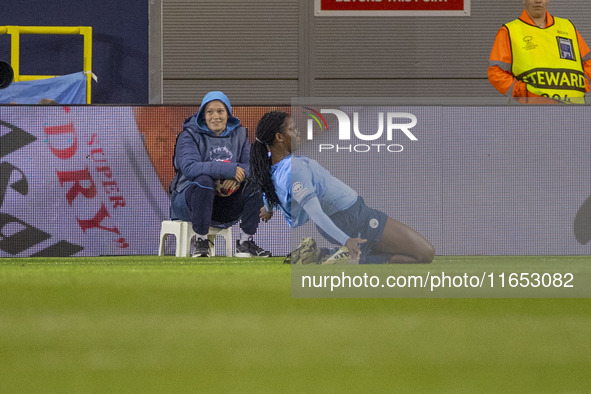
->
[315,0,470,16]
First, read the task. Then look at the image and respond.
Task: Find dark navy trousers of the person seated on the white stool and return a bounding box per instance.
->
[185,175,263,234]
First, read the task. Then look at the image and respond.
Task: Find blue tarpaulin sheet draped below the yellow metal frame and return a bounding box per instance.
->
[0,72,86,104]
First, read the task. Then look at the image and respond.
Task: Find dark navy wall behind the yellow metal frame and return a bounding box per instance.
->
[0,0,148,104]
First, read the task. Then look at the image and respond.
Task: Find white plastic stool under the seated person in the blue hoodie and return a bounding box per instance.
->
[158,220,233,257]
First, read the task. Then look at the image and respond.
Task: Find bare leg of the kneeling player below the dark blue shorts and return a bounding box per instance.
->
[372,217,435,263]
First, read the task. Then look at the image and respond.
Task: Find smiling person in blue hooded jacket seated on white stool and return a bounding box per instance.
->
[170,91,271,257]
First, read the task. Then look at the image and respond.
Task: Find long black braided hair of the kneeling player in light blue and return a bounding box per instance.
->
[250,111,289,205]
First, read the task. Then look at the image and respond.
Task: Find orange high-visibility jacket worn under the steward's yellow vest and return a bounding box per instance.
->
[488,10,591,101]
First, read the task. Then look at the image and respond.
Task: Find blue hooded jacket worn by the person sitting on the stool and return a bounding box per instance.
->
[170,91,250,193]
